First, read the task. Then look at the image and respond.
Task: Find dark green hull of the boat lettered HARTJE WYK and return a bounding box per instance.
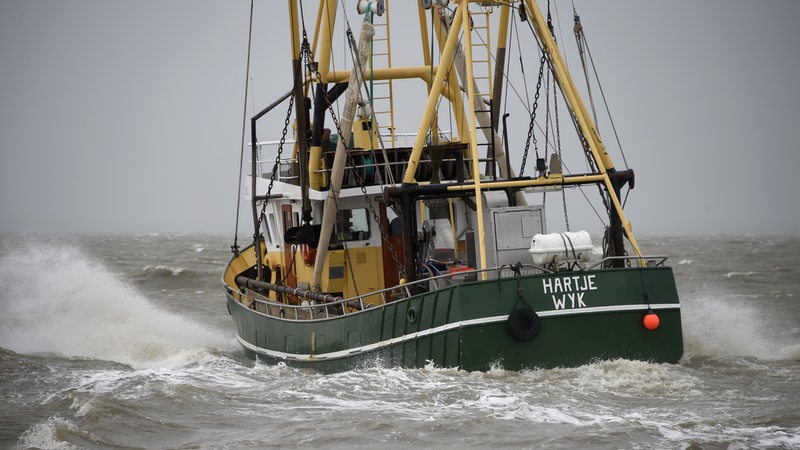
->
[227,267,683,371]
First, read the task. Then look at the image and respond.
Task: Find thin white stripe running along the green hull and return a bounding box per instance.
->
[236,303,681,362]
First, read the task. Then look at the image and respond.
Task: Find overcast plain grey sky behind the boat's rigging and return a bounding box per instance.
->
[0,0,800,235]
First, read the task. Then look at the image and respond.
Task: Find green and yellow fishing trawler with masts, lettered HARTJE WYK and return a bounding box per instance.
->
[222,0,683,371]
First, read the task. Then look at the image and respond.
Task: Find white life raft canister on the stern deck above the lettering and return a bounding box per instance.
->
[529,231,594,266]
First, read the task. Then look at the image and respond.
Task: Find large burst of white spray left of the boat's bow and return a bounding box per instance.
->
[0,244,230,367]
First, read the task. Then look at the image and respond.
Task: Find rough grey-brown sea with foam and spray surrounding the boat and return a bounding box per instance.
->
[0,235,800,449]
